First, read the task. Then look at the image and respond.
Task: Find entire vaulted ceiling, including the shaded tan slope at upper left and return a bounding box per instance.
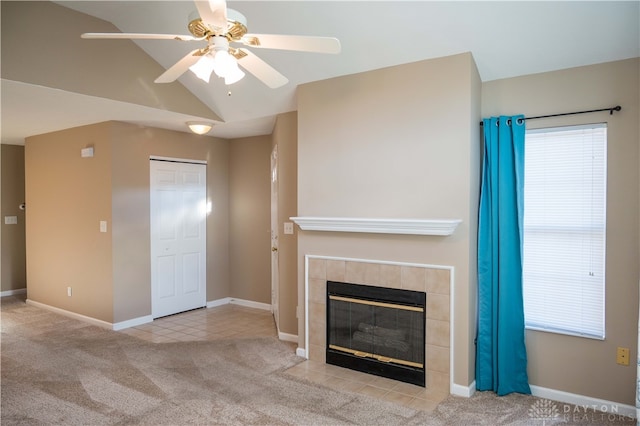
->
[0,0,640,144]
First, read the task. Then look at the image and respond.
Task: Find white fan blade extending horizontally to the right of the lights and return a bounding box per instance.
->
[240,34,340,53]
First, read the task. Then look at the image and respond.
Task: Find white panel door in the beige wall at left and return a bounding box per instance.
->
[150,160,207,318]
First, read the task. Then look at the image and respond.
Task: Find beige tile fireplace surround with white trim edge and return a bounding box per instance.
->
[305,255,453,395]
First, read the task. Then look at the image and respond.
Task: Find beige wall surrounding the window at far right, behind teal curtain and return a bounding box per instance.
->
[482,58,640,405]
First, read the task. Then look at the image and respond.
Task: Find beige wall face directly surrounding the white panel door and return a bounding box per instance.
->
[110,122,230,322]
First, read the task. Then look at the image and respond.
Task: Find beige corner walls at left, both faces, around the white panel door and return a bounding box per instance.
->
[25,122,232,323]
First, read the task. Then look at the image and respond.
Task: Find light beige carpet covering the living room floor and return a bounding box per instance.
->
[1,297,635,425]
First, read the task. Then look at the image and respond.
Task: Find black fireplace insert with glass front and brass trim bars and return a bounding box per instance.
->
[326,281,426,386]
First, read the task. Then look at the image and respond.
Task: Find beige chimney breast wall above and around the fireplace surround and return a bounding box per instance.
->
[298,54,480,386]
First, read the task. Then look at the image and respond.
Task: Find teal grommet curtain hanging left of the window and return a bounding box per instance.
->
[476,115,531,395]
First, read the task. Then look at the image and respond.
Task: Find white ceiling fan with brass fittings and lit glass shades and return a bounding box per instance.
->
[81,0,340,89]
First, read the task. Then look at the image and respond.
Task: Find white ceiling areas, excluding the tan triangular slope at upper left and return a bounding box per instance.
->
[1,0,640,144]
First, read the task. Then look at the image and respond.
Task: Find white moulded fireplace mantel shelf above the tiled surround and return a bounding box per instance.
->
[290,216,462,236]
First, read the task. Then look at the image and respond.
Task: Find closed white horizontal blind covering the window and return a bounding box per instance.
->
[523,124,607,339]
